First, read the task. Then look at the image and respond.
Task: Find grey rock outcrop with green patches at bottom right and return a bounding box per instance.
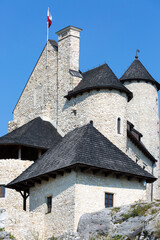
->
[58,201,160,240]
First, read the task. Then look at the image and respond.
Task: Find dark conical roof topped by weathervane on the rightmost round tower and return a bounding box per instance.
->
[120,59,160,90]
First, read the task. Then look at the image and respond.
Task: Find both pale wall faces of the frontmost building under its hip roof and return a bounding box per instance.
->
[30,171,146,238]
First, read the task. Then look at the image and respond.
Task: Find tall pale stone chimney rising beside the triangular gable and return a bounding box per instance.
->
[56,26,82,93]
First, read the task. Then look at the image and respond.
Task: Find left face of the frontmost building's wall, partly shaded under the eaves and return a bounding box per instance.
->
[30,172,76,238]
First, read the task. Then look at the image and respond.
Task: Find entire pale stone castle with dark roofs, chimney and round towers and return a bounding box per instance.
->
[0,26,160,239]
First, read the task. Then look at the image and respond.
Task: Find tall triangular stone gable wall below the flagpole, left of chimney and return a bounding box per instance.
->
[12,42,57,130]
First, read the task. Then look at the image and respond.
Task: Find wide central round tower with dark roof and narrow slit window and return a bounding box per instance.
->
[64,64,132,152]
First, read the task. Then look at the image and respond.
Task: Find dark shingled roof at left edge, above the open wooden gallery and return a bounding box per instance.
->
[0,117,62,149]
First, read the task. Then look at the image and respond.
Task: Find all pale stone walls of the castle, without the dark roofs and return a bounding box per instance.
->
[3,26,160,240]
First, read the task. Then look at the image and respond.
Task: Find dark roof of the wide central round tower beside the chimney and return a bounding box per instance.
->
[65,63,133,100]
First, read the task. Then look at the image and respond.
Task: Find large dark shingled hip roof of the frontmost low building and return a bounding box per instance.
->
[8,124,156,188]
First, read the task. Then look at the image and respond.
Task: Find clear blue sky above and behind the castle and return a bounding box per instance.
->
[0,0,160,136]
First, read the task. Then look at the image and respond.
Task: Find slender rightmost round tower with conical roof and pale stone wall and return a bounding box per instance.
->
[120,56,160,199]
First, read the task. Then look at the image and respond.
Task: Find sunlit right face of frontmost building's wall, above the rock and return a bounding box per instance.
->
[75,172,146,230]
